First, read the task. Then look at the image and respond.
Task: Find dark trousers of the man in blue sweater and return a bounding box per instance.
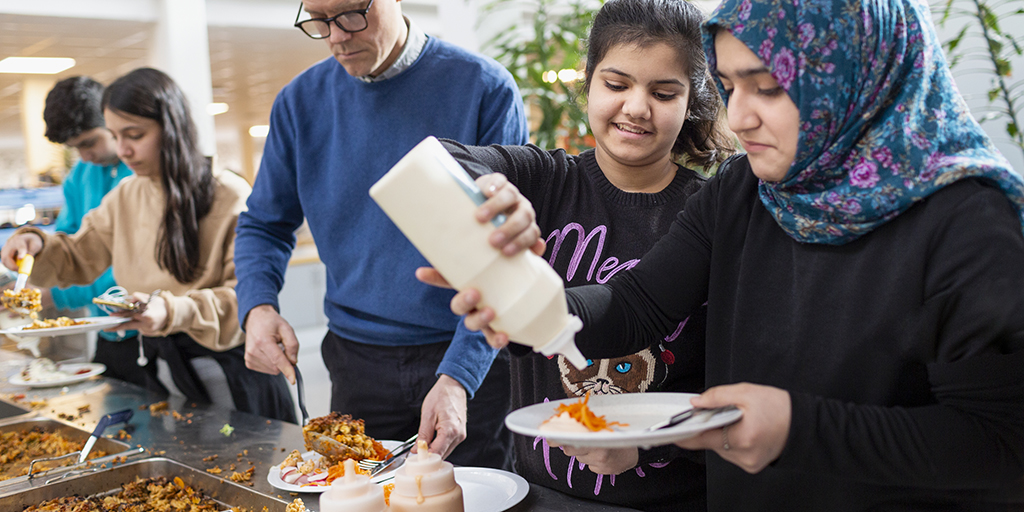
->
[321,331,512,471]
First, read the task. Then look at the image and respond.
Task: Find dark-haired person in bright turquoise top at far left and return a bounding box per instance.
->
[41,77,138,385]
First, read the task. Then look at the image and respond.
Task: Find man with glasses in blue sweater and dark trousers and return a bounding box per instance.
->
[234,0,531,469]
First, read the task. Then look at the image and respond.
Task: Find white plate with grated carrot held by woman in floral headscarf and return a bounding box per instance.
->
[505,393,742,447]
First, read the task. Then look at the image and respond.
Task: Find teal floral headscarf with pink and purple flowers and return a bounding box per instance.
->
[705,0,1024,245]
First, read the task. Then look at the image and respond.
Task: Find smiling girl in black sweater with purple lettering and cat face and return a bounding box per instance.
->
[436,0,731,511]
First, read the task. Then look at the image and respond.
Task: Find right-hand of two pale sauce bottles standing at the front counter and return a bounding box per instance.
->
[390,440,465,512]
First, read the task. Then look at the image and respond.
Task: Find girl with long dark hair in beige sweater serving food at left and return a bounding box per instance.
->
[0,69,295,421]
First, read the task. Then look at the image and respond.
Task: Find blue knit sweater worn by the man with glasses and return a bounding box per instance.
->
[234,38,527,394]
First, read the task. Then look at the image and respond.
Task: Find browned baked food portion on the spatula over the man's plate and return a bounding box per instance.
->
[302,412,389,465]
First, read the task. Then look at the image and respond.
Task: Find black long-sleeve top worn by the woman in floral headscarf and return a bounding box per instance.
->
[567,156,1024,512]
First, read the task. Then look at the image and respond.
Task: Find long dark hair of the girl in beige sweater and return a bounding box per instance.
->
[102,68,214,283]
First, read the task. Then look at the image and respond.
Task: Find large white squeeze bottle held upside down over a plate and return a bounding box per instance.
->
[370,137,587,369]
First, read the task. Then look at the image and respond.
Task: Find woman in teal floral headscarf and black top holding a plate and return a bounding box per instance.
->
[436,0,1024,512]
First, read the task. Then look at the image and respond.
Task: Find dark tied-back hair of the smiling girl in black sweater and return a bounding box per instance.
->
[584,0,735,169]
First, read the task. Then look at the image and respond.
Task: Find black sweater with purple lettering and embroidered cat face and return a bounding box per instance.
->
[442,141,707,512]
